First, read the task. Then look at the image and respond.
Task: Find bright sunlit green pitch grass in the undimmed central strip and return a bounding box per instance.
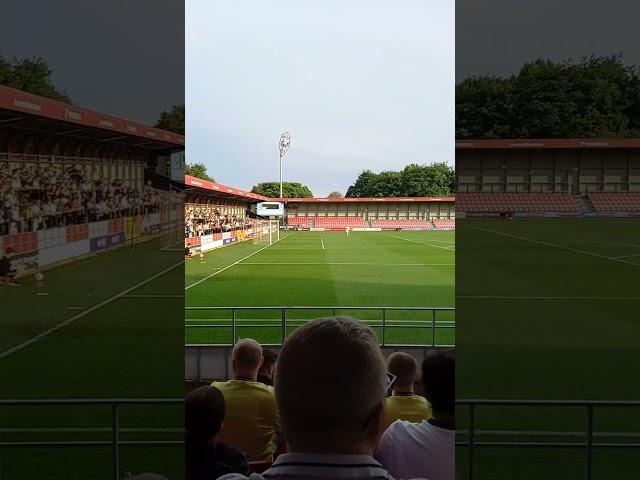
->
[185,232,455,345]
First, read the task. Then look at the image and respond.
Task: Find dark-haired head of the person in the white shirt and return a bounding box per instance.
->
[422,348,456,417]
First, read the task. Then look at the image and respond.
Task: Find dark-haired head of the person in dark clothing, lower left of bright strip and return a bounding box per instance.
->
[184,387,225,444]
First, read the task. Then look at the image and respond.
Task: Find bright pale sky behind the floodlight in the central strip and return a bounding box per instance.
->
[185,0,455,196]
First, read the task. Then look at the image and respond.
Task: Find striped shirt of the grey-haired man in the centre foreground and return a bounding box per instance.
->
[219,453,428,480]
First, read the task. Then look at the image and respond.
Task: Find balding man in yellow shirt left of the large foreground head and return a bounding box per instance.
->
[212,338,282,462]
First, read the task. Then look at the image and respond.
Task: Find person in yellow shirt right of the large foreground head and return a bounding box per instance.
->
[384,352,431,429]
